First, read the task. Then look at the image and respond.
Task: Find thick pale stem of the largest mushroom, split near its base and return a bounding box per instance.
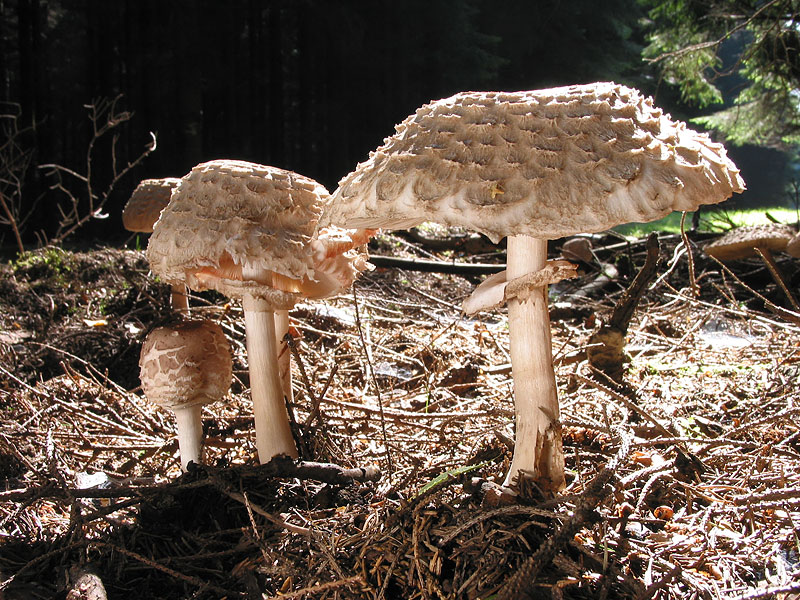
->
[505,235,565,493]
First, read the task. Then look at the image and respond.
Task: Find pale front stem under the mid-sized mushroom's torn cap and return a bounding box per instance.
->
[242,267,297,464]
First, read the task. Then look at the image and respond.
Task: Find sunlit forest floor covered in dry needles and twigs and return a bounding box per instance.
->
[0,227,800,600]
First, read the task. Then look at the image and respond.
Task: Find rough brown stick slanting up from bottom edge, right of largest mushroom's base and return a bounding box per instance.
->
[496,430,631,600]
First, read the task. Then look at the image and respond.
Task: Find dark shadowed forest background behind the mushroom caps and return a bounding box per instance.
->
[0,0,786,244]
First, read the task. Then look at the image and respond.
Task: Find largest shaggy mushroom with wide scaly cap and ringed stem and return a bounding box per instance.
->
[324,83,743,492]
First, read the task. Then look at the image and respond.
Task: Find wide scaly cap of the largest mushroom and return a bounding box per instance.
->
[323,83,744,241]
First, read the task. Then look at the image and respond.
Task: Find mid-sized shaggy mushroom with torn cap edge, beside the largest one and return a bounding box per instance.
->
[147,160,366,463]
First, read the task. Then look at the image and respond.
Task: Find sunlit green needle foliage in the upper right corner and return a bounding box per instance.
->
[642,0,800,148]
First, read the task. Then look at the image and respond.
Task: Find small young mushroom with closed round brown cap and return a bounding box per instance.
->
[139,320,233,471]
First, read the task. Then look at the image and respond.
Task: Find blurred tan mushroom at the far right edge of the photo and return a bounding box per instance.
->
[705,223,800,310]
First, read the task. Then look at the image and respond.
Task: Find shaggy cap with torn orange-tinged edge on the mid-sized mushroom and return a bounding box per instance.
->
[147,160,366,309]
